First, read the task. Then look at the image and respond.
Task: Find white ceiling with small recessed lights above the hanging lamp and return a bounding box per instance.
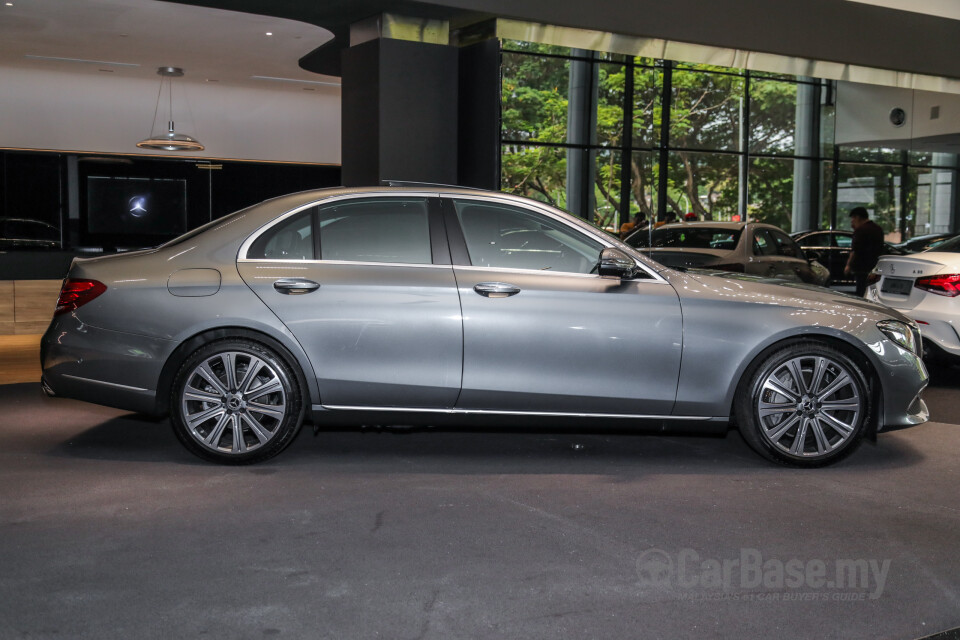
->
[0,0,340,91]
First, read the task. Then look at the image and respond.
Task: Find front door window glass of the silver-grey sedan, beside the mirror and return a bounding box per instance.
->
[454,200,603,273]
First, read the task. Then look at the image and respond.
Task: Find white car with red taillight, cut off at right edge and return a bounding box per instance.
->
[864,237,960,361]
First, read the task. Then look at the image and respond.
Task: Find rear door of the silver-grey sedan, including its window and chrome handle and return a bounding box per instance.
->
[237,194,462,408]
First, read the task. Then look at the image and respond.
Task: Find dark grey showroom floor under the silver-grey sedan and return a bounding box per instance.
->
[0,371,960,640]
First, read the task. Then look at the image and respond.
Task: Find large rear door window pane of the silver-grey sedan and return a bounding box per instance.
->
[318,198,433,264]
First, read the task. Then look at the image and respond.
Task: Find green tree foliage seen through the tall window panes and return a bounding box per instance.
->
[502,43,796,228]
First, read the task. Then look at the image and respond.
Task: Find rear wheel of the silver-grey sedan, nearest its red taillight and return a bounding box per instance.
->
[170,338,305,464]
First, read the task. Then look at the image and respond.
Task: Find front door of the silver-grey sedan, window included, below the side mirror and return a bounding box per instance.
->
[444,197,683,415]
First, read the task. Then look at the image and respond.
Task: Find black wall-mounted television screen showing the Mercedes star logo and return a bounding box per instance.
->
[85,175,187,240]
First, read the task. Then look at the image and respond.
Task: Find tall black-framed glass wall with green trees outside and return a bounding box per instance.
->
[501,41,957,241]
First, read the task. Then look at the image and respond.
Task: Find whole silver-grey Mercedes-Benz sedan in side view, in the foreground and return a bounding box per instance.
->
[41,187,927,466]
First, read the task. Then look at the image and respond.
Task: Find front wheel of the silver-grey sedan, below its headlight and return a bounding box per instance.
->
[734,341,871,467]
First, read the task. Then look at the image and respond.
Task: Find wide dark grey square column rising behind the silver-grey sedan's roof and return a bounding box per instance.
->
[340,38,458,186]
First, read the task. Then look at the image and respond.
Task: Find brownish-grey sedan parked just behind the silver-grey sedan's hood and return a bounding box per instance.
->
[624,222,830,286]
